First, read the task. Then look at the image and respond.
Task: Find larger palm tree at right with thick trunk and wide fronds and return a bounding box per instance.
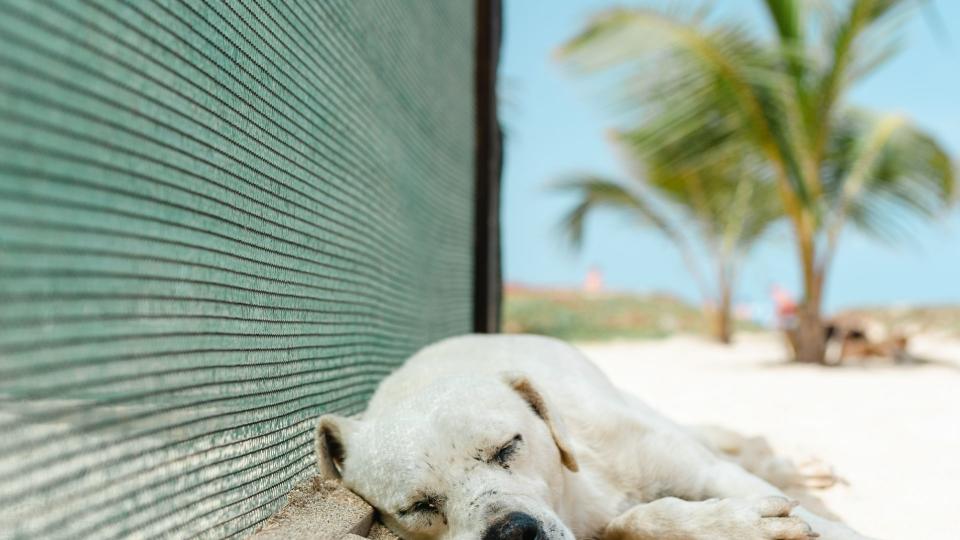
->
[560,0,955,362]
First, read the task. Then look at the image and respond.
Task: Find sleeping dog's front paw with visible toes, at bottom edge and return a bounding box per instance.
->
[704,497,820,540]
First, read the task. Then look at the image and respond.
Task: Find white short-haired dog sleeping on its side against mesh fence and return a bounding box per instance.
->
[317,336,863,540]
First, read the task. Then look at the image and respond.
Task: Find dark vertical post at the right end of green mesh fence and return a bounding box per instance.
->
[473,0,503,333]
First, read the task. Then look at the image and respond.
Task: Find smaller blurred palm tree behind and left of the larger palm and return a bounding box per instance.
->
[558,131,779,343]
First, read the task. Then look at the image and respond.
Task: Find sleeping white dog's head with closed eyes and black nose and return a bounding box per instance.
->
[317,374,577,540]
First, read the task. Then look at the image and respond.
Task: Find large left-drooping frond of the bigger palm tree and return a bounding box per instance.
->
[560,9,809,213]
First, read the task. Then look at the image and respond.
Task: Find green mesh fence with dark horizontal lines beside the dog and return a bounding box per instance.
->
[0,0,474,538]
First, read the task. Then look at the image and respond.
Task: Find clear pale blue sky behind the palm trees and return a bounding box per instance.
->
[500,0,960,310]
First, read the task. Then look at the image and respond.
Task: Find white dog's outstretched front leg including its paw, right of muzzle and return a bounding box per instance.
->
[602,497,817,540]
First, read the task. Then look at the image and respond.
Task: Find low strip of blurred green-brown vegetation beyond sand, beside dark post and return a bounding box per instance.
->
[503,287,756,341]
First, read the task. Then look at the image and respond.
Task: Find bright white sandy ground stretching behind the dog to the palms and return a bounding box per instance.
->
[580,335,960,540]
